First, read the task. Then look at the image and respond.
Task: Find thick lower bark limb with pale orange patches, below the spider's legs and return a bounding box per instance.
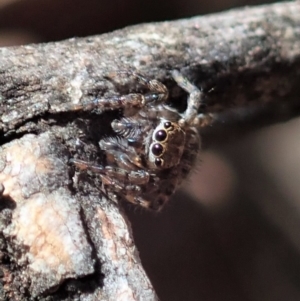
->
[0,132,157,301]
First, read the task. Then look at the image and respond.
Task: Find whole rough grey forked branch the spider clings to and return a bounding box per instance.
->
[0,2,300,300]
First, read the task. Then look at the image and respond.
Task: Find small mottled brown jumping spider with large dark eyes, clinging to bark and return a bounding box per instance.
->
[72,71,202,210]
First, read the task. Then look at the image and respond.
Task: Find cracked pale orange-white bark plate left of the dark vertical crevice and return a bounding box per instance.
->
[0,134,94,295]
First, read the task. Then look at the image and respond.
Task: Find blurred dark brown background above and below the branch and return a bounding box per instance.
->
[0,0,300,301]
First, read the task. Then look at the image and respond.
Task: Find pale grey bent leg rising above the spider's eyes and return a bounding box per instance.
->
[172,70,203,124]
